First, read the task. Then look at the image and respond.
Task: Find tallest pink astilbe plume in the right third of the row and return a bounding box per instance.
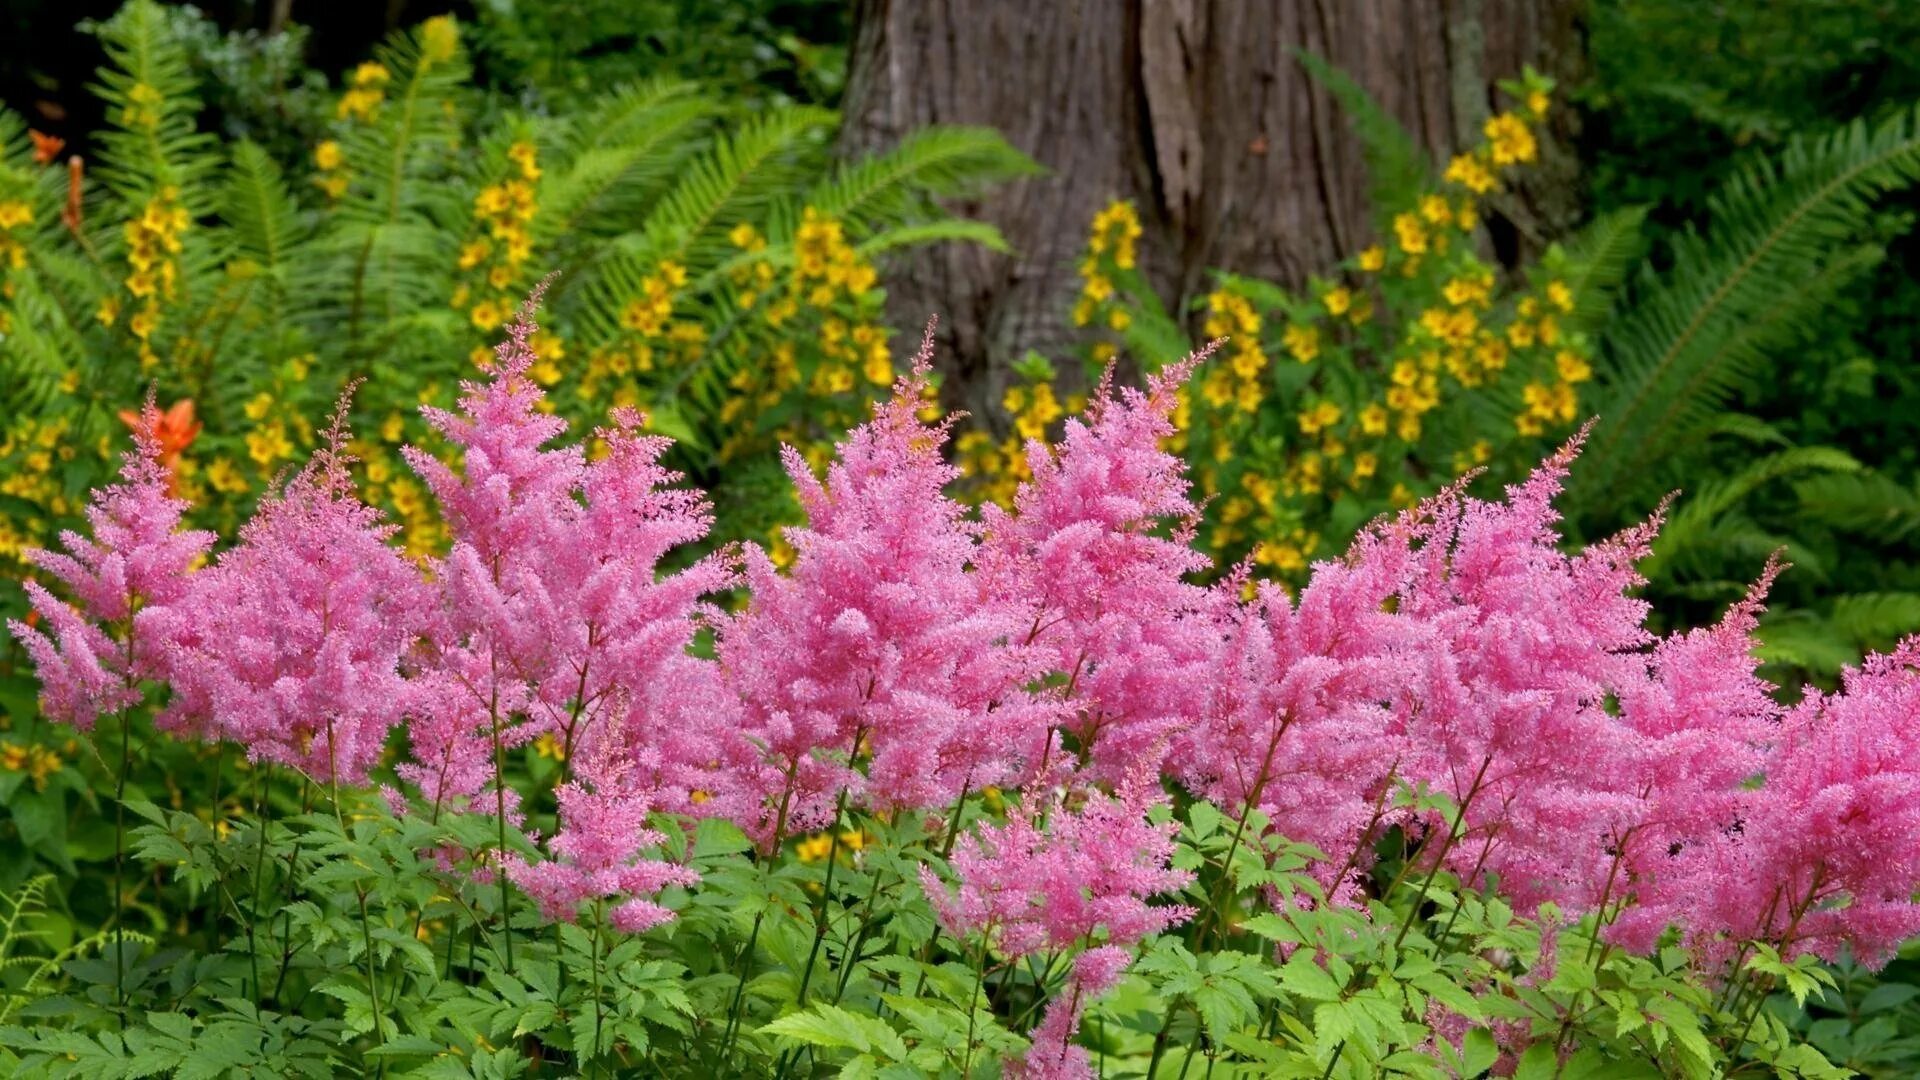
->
[1380,436,1655,909]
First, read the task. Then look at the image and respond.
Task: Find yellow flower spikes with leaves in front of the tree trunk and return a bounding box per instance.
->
[1044,75,1592,575]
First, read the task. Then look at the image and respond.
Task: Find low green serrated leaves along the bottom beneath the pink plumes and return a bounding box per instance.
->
[0,737,1866,1078]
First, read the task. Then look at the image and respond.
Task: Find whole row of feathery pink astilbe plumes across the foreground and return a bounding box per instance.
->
[13,286,1920,1076]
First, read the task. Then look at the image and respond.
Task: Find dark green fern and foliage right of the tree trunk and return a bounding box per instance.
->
[1574,0,1920,684]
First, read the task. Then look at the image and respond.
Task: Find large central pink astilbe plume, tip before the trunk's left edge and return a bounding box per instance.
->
[720,327,1048,844]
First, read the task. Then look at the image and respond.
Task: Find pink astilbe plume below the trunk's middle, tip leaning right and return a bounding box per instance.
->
[981,342,1219,782]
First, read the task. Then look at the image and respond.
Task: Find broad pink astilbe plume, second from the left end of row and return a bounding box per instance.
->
[150,402,426,784]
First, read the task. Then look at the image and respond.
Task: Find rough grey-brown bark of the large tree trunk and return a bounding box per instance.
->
[841,0,1580,415]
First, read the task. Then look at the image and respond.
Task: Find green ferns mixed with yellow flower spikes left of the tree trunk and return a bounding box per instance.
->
[0,0,1035,580]
